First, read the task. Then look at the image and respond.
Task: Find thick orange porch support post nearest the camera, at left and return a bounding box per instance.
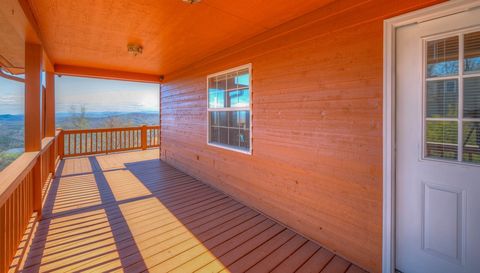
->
[25,43,43,219]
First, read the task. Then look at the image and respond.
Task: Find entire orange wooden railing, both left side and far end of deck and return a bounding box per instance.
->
[0,126,160,272]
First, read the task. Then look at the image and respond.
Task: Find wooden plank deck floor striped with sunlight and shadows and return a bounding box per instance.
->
[15,150,364,273]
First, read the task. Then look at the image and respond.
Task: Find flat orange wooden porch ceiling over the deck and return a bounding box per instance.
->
[23,0,338,79]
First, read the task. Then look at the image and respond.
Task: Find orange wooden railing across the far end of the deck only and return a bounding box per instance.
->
[59,125,160,157]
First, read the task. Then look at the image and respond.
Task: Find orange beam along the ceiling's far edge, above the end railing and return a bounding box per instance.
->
[55,64,163,83]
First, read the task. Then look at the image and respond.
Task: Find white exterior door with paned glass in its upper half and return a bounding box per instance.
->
[395,6,480,273]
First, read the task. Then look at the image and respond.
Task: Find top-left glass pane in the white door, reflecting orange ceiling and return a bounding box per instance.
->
[427,36,458,78]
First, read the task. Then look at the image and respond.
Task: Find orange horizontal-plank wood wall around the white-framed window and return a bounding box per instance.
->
[161,0,439,272]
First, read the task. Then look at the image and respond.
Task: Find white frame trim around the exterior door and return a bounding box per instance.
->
[382,0,480,273]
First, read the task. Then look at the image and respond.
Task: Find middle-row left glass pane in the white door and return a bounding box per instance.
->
[427,79,458,118]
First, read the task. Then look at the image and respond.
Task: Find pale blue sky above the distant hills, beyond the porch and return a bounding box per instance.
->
[0,76,159,114]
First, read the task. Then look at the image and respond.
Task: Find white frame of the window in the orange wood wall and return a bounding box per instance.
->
[206,63,253,155]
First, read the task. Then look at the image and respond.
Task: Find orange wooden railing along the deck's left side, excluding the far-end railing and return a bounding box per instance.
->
[0,131,58,272]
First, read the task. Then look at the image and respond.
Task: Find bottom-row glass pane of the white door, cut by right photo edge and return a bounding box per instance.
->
[463,121,480,163]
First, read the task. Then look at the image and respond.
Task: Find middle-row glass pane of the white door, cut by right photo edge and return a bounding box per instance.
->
[463,77,480,118]
